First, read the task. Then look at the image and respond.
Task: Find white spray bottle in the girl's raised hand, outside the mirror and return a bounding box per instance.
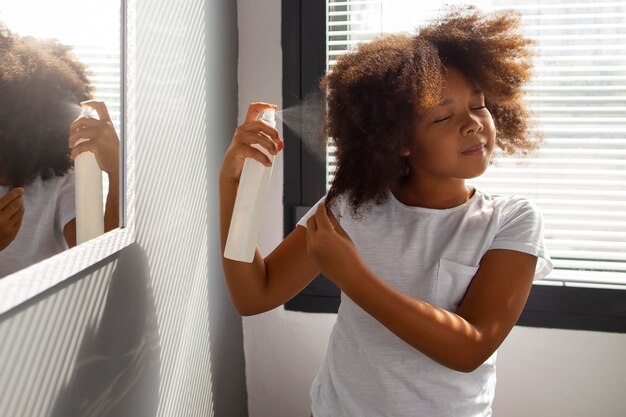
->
[224,109,276,263]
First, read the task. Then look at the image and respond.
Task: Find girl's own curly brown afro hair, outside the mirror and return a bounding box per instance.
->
[321,6,538,214]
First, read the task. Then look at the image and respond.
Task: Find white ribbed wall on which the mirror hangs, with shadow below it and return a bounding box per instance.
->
[0,0,247,417]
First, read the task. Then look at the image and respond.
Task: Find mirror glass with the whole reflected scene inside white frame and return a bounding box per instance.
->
[0,0,122,278]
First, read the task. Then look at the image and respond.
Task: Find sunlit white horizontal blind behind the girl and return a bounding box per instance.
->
[327,0,626,288]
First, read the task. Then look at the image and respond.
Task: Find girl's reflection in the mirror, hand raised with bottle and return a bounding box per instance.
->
[0,25,119,277]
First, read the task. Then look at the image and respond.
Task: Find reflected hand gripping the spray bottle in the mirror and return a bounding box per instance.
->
[69,100,120,176]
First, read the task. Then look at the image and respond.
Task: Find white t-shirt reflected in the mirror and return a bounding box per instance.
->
[0,170,76,278]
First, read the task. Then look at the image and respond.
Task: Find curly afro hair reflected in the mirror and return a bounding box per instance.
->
[0,24,93,187]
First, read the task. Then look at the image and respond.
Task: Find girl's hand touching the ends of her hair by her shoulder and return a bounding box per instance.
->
[306,204,365,288]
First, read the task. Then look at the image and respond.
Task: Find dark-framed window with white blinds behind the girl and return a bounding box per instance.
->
[283,0,626,332]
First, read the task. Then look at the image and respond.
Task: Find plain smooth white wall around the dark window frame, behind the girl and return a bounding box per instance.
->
[238,0,626,417]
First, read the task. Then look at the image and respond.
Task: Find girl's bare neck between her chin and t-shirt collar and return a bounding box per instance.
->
[391,178,474,209]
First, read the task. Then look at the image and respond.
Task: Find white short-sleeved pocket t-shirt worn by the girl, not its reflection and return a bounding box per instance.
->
[298,190,552,417]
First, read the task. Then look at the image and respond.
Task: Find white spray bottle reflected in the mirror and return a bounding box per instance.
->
[74,105,104,244]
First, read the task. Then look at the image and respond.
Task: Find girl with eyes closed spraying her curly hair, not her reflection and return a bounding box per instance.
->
[220,7,552,417]
